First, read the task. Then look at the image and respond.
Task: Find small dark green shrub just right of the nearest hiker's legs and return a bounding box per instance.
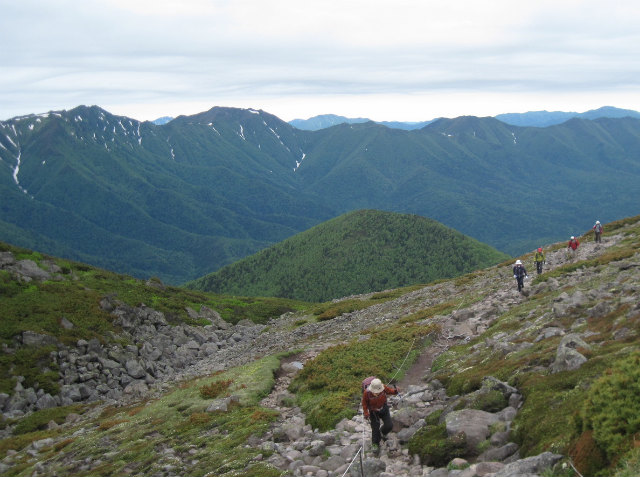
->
[408,423,467,467]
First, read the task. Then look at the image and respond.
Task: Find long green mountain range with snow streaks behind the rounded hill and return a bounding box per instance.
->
[0,106,640,284]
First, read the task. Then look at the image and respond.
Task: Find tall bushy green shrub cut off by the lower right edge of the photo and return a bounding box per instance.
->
[581,352,640,460]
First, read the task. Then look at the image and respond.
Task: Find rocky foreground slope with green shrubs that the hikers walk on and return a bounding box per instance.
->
[0,217,640,477]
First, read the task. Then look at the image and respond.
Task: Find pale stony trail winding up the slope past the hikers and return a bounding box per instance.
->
[225,237,620,477]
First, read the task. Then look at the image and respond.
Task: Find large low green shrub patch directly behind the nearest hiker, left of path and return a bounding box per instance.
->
[290,325,436,431]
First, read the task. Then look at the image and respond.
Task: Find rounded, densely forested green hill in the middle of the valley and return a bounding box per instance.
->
[188,210,507,301]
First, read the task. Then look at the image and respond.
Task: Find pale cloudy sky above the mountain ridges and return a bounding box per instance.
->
[0,0,640,121]
